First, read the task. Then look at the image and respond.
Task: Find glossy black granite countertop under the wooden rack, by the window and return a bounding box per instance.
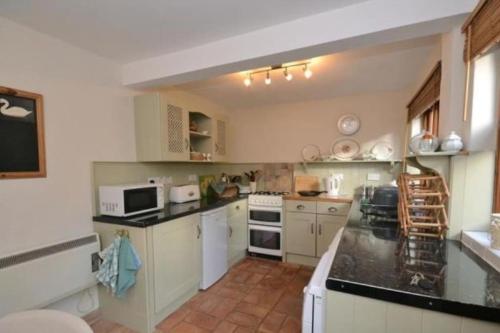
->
[326,196,500,322]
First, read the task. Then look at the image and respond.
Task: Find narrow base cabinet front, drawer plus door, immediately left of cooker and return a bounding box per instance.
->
[227,200,248,266]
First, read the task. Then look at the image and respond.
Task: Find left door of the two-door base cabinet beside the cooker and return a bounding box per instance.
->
[285,212,316,257]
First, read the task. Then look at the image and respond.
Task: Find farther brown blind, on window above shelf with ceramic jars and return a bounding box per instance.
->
[407,61,441,121]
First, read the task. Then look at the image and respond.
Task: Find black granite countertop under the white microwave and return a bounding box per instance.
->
[93,195,248,228]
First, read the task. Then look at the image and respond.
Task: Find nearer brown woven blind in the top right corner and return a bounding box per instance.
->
[462,0,500,62]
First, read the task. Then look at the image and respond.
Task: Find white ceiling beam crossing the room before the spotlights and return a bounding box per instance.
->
[122,0,477,88]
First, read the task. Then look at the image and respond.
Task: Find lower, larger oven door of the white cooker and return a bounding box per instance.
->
[248,224,283,257]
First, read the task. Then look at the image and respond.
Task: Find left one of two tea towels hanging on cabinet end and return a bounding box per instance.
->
[96,237,121,294]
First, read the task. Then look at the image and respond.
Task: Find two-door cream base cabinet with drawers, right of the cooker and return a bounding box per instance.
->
[285,200,351,265]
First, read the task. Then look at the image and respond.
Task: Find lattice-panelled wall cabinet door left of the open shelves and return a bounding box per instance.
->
[162,97,189,161]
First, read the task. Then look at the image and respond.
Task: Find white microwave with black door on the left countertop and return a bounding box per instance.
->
[99,184,165,217]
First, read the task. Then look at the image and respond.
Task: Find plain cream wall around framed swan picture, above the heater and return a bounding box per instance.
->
[0,18,135,314]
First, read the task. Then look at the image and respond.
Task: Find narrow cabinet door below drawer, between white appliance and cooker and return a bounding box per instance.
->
[228,212,248,265]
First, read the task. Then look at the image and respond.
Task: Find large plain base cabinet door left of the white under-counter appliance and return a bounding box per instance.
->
[153,214,201,313]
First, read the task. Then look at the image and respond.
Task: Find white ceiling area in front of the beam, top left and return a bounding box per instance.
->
[0,0,368,63]
